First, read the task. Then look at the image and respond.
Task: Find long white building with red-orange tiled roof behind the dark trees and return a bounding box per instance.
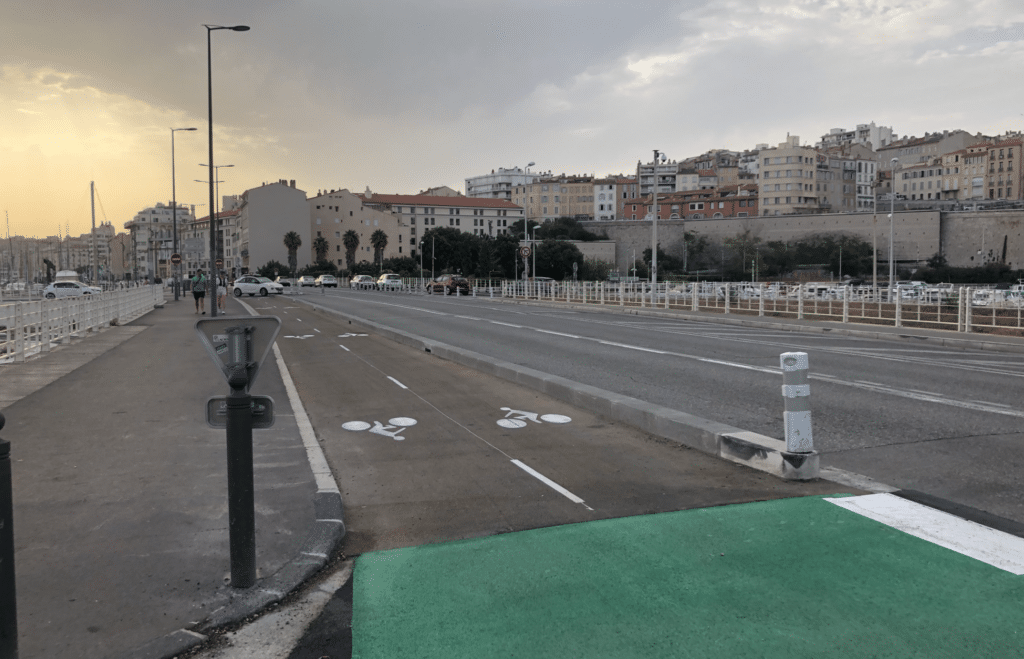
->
[361,189,523,255]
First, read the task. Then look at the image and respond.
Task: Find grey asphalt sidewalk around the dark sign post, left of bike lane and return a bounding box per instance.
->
[0,296,340,659]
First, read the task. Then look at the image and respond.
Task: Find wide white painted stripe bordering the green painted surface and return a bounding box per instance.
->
[824,493,1024,576]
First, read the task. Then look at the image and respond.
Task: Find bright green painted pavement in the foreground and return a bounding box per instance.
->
[352,496,1024,659]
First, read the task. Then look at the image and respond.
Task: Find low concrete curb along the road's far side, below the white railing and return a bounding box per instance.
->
[493,298,1024,353]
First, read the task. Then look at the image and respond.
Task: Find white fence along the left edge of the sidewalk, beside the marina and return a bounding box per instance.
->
[0,285,164,364]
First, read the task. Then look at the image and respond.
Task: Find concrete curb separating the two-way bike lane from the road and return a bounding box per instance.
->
[303,300,819,480]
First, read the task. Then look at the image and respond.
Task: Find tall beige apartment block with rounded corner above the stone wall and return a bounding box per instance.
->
[758,135,819,215]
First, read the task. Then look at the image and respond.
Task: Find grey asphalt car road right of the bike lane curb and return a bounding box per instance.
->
[286,289,1024,522]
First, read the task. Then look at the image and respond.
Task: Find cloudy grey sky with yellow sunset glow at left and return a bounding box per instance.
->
[0,0,1024,237]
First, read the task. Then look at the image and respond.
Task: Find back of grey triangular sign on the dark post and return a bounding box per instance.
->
[196,316,281,391]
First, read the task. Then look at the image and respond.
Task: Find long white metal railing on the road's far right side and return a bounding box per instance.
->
[501,280,1024,336]
